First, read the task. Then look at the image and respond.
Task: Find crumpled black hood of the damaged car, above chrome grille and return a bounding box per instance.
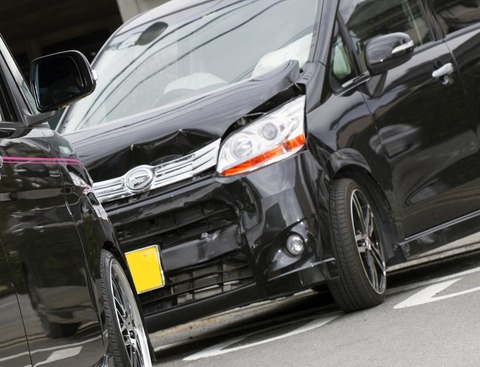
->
[61,61,299,181]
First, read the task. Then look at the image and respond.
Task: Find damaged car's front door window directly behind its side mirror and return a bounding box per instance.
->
[342,0,433,71]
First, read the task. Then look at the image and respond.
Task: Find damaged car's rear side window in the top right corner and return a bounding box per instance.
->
[433,0,480,35]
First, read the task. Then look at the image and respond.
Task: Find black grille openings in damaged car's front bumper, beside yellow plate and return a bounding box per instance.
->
[109,199,254,315]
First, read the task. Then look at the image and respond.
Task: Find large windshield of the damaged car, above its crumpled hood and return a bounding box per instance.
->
[62,0,319,132]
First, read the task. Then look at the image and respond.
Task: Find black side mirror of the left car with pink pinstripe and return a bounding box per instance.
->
[30,51,96,112]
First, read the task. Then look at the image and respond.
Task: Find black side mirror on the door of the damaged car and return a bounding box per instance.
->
[365,32,415,75]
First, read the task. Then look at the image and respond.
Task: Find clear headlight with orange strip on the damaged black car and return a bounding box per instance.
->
[217,96,305,176]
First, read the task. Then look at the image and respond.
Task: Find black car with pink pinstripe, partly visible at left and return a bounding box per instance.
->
[0,38,152,367]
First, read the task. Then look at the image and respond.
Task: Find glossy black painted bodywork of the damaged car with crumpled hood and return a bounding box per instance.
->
[59,1,480,331]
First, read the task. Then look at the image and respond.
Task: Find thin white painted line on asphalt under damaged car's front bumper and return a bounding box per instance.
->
[183,311,343,361]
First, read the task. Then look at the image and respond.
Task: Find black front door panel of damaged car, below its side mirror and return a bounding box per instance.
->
[367,41,480,236]
